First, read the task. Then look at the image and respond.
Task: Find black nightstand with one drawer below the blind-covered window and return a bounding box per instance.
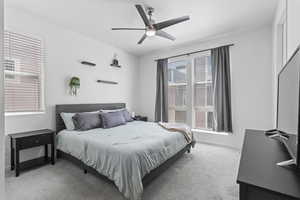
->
[9,129,55,177]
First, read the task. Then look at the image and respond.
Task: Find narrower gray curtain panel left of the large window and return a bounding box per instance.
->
[155,59,168,122]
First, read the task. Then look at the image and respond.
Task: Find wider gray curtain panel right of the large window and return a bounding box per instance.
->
[211,46,232,133]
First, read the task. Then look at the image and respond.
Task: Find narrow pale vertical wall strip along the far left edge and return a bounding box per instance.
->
[0,0,5,195]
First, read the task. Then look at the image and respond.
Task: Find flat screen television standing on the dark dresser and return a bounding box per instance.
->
[276,46,300,168]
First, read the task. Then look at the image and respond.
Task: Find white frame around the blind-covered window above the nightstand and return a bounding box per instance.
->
[3,27,46,114]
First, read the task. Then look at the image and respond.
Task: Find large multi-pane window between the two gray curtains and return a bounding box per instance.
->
[168,51,213,130]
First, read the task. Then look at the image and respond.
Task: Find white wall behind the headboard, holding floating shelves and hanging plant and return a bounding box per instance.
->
[5,8,138,166]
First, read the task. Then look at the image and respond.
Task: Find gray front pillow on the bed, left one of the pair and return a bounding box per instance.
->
[72,112,102,131]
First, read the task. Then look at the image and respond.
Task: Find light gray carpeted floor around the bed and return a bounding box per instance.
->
[6,144,239,200]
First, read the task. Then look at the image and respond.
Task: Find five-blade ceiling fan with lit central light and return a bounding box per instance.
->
[112,4,190,44]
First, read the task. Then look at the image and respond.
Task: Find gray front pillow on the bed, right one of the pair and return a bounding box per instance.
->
[100,111,126,128]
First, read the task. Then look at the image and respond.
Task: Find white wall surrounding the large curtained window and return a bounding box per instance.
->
[138,26,274,148]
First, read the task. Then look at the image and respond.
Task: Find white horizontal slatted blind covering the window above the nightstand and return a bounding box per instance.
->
[4,31,43,112]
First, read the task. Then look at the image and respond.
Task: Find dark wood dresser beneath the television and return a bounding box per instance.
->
[237,130,300,200]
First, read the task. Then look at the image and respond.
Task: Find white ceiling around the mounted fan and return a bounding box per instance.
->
[5,0,278,55]
